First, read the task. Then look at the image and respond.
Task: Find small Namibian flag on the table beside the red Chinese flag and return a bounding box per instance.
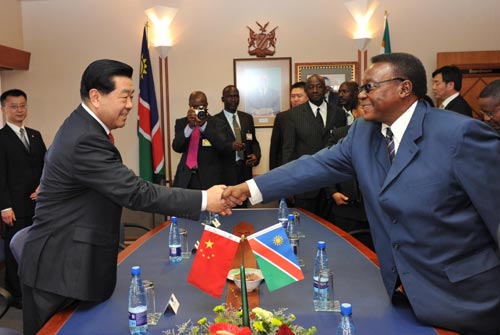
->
[247,223,304,292]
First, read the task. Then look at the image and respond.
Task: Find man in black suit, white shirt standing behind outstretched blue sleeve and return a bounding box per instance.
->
[282,74,347,218]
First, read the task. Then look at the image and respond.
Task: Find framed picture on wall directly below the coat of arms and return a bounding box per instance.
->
[233,57,292,127]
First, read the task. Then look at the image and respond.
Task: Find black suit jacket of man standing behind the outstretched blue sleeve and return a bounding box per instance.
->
[282,102,347,199]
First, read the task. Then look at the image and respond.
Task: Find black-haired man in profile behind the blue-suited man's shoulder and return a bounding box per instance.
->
[432,65,472,117]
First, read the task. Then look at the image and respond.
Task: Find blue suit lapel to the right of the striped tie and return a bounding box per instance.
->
[381,102,427,191]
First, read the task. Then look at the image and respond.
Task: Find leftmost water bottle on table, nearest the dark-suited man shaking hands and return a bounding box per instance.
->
[128,266,148,335]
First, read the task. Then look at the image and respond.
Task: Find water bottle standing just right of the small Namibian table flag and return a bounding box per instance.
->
[313,241,333,311]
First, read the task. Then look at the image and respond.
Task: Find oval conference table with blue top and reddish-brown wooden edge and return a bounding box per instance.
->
[40,209,454,335]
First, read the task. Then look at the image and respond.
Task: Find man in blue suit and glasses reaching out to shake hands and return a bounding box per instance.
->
[223,53,500,334]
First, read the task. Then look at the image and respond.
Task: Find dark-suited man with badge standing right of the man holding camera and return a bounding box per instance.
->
[214,85,261,207]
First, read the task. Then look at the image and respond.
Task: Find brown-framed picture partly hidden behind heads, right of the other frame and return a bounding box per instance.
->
[295,62,359,91]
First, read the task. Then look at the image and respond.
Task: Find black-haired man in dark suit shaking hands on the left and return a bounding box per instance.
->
[21,60,229,334]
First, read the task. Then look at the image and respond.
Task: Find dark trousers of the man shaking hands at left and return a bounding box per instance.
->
[23,285,76,335]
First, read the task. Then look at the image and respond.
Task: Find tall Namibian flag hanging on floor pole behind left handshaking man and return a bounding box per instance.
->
[137,27,165,184]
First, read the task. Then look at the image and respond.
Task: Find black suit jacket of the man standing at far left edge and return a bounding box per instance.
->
[0,125,47,220]
